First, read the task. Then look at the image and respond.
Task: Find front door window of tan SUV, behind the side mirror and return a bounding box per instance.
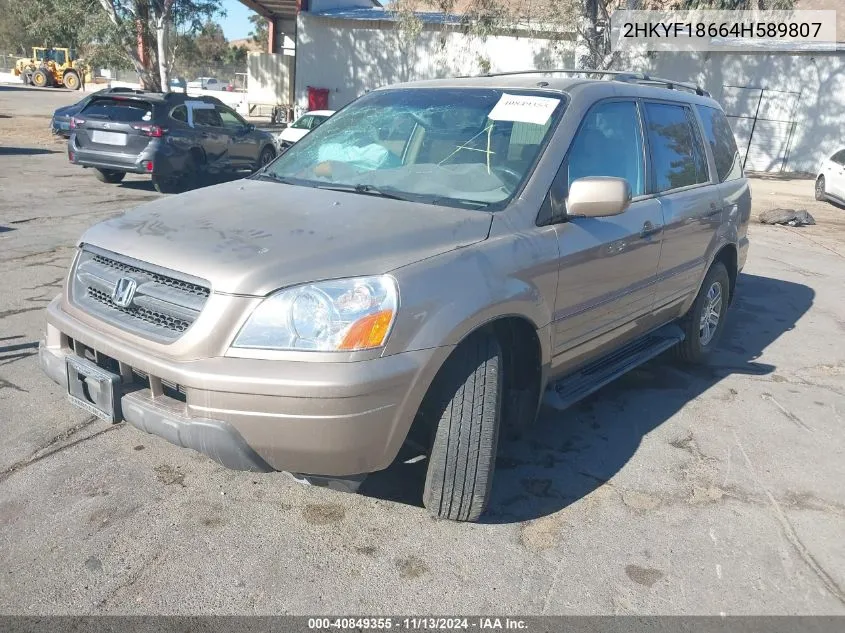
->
[563,101,646,197]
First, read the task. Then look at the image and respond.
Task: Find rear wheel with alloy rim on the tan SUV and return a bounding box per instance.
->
[675,262,731,363]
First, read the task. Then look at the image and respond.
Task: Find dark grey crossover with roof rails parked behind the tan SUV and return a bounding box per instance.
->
[68,92,276,193]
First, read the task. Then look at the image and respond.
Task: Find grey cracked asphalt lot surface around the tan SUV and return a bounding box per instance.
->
[0,86,845,615]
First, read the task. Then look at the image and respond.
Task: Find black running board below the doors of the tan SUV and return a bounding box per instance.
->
[543,324,685,409]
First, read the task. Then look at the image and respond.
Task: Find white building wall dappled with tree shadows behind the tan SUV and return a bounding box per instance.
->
[295,14,845,172]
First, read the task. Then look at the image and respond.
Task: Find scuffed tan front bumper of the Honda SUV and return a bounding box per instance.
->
[39,298,451,477]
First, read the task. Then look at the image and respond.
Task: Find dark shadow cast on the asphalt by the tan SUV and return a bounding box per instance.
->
[359,274,815,523]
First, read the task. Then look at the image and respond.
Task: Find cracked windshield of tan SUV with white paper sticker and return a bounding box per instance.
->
[269,88,565,208]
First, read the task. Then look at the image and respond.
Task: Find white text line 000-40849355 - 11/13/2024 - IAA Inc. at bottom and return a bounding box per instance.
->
[308,617,528,631]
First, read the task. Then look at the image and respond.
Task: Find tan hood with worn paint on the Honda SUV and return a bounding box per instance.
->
[81,180,492,296]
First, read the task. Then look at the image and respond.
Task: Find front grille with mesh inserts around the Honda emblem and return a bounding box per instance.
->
[71,246,211,342]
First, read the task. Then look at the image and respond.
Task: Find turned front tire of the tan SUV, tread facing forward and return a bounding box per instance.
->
[423,332,502,521]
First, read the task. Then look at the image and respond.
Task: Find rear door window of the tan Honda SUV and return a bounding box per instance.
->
[645,103,708,193]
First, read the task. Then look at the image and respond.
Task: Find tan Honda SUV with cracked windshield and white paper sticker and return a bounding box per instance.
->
[39,70,751,521]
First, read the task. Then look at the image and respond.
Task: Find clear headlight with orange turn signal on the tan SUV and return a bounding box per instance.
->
[232,275,399,352]
